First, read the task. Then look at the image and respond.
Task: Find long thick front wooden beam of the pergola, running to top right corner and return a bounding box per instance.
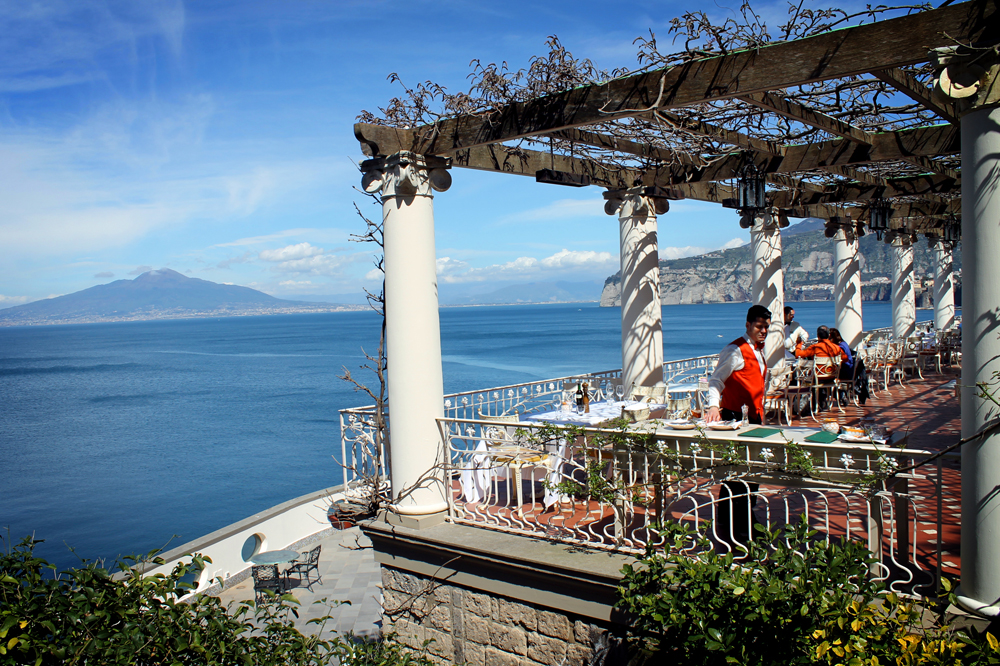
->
[356,0,1000,155]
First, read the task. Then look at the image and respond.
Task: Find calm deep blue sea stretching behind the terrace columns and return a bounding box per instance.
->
[0,301,916,568]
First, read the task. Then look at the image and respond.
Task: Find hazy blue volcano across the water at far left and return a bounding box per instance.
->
[0,268,357,326]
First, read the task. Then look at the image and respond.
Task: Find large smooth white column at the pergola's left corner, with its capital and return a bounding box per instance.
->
[362,153,451,516]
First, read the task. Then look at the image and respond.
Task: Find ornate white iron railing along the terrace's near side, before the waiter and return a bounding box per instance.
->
[439,418,942,592]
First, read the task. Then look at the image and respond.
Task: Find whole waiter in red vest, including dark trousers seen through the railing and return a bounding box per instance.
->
[705,305,771,548]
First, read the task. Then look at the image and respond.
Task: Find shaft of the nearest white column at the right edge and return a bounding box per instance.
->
[959,107,1000,615]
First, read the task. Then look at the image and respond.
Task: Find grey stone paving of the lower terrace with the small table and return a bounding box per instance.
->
[219,527,382,636]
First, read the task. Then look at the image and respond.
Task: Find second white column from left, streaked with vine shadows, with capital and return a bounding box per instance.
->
[605,189,666,388]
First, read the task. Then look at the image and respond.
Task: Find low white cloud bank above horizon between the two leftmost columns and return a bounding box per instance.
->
[438,249,618,283]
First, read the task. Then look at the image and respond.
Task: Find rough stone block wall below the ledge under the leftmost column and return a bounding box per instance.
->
[382,565,615,666]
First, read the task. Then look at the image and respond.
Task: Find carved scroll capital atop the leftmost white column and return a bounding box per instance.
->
[361,151,451,199]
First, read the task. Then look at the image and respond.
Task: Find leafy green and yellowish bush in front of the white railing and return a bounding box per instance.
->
[619,519,1000,666]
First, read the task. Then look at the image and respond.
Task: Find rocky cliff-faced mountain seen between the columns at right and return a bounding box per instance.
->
[601,218,962,307]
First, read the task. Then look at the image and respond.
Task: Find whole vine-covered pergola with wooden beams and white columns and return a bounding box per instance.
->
[355,0,1000,615]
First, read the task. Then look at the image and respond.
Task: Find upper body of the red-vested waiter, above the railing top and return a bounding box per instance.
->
[705,305,771,424]
